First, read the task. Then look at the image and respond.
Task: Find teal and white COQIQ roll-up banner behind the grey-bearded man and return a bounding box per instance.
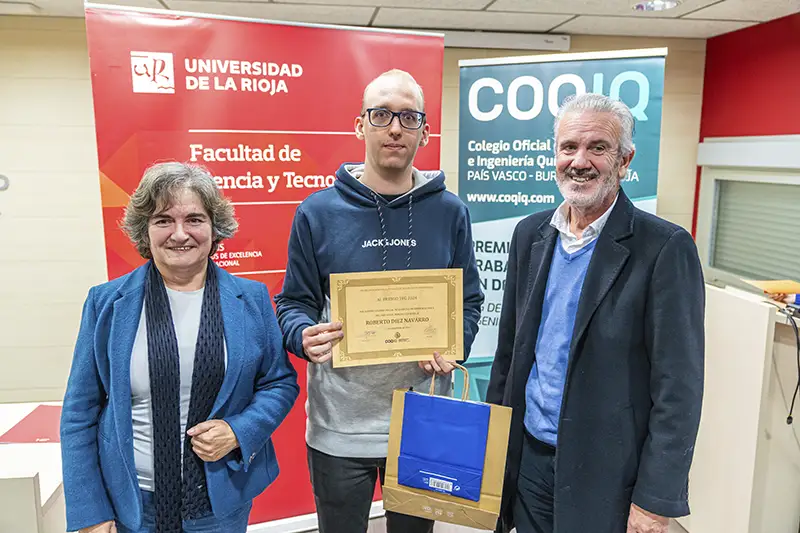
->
[456,48,667,400]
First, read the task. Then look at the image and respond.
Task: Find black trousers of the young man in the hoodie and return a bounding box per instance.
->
[308,447,433,533]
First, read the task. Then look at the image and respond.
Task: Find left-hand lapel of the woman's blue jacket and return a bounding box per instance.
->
[108,264,148,446]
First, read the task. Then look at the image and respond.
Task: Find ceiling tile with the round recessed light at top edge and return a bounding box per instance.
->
[489,0,720,18]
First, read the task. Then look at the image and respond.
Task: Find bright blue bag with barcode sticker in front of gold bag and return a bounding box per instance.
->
[397,365,491,502]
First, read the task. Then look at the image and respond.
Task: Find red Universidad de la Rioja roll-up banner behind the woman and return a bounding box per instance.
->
[86,4,444,523]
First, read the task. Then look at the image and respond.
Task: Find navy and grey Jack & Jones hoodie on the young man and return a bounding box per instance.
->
[275,164,483,457]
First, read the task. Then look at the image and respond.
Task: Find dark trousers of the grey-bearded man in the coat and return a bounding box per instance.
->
[514,431,556,533]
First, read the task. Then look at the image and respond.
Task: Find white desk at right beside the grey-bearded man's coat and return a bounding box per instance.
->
[679,285,800,533]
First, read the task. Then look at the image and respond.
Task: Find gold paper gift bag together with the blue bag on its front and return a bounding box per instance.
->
[383,365,511,530]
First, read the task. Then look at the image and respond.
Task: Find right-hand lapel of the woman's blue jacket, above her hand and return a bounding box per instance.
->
[210,265,245,418]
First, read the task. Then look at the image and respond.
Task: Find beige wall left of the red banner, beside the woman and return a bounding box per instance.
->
[0,17,106,401]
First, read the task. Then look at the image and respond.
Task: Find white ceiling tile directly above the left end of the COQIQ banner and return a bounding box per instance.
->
[373,8,569,32]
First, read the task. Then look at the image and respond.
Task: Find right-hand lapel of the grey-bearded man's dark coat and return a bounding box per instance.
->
[570,189,634,359]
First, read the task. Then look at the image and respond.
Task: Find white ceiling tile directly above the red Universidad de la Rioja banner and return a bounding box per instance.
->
[166,0,375,26]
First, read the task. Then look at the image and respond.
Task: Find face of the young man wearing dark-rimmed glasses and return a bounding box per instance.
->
[355,75,430,173]
